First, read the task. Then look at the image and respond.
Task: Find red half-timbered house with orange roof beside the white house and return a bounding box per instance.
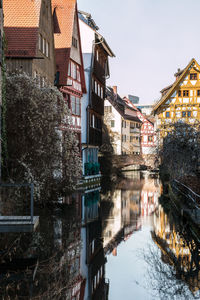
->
[52,0,86,148]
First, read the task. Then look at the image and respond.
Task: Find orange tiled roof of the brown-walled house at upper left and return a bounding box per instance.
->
[3,0,42,57]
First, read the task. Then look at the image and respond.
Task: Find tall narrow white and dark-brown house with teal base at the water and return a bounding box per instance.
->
[79,12,114,175]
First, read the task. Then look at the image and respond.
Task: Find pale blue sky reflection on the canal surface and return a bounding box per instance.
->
[106,217,160,300]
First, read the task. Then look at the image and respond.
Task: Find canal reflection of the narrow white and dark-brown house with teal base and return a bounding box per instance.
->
[81,189,108,300]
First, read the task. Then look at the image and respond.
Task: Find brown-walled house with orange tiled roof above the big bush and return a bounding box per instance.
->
[4,0,55,86]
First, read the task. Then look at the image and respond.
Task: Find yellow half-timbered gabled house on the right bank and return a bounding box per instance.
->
[153,58,200,137]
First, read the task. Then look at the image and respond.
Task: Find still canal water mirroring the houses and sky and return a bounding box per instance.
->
[0,171,200,300]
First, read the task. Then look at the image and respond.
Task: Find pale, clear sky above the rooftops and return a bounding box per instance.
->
[77,0,200,104]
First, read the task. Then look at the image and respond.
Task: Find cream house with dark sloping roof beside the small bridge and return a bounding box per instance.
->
[104,87,142,155]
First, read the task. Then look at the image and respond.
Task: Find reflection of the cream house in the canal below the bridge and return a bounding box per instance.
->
[102,172,141,256]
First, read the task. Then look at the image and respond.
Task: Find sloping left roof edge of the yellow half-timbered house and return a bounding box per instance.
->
[152,58,197,112]
